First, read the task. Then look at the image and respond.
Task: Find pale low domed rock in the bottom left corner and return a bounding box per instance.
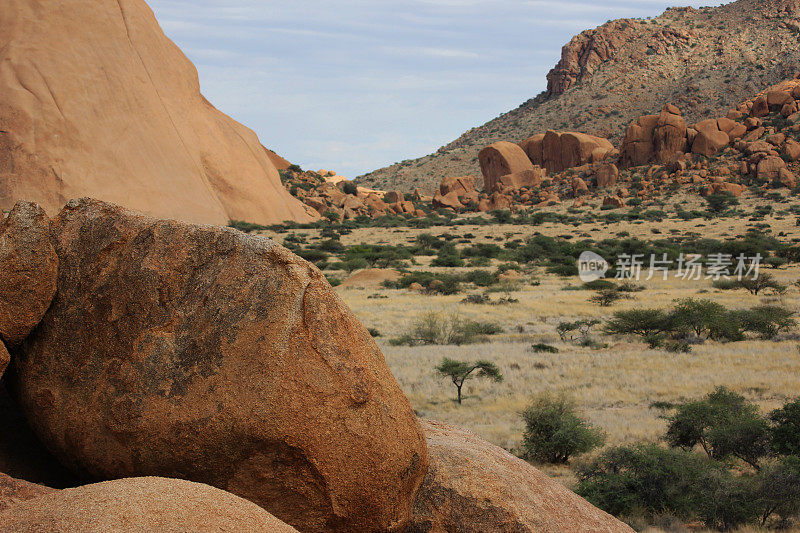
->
[0,477,297,533]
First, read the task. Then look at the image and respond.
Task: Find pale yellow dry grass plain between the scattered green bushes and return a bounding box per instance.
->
[339,269,800,450]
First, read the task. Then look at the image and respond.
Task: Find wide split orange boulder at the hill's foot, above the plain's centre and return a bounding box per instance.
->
[520,130,614,174]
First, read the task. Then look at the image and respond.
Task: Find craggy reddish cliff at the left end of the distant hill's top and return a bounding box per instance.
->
[547,20,634,96]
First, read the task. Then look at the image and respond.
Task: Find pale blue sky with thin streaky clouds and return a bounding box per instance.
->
[149,0,723,178]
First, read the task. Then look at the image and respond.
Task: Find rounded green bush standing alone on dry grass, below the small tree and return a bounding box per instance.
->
[522,395,605,464]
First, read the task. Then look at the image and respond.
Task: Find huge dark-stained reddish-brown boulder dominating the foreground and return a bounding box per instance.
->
[11,199,428,531]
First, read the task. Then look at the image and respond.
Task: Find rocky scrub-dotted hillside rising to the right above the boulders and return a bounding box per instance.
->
[357,0,800,192]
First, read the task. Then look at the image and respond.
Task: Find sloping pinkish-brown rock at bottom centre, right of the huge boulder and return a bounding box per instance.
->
[409,421,633,533]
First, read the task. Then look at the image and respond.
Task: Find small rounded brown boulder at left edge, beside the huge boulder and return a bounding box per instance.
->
[0,202,58,344]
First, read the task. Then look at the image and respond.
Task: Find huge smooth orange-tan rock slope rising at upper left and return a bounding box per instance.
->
[0,0,318,224]
